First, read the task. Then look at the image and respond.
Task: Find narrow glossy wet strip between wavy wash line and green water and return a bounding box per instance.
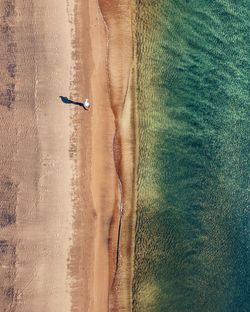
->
[99,0,137,311]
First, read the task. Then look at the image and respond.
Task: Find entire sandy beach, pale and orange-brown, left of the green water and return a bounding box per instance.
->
[0,0,136,312]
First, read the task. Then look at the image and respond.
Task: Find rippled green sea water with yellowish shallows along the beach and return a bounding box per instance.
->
[133,0,250,312]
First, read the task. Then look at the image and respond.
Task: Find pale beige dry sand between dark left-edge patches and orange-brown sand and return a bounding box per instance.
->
[0,0,73,312]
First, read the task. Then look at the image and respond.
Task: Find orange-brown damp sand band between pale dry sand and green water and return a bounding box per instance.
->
[70,0,136,312]
